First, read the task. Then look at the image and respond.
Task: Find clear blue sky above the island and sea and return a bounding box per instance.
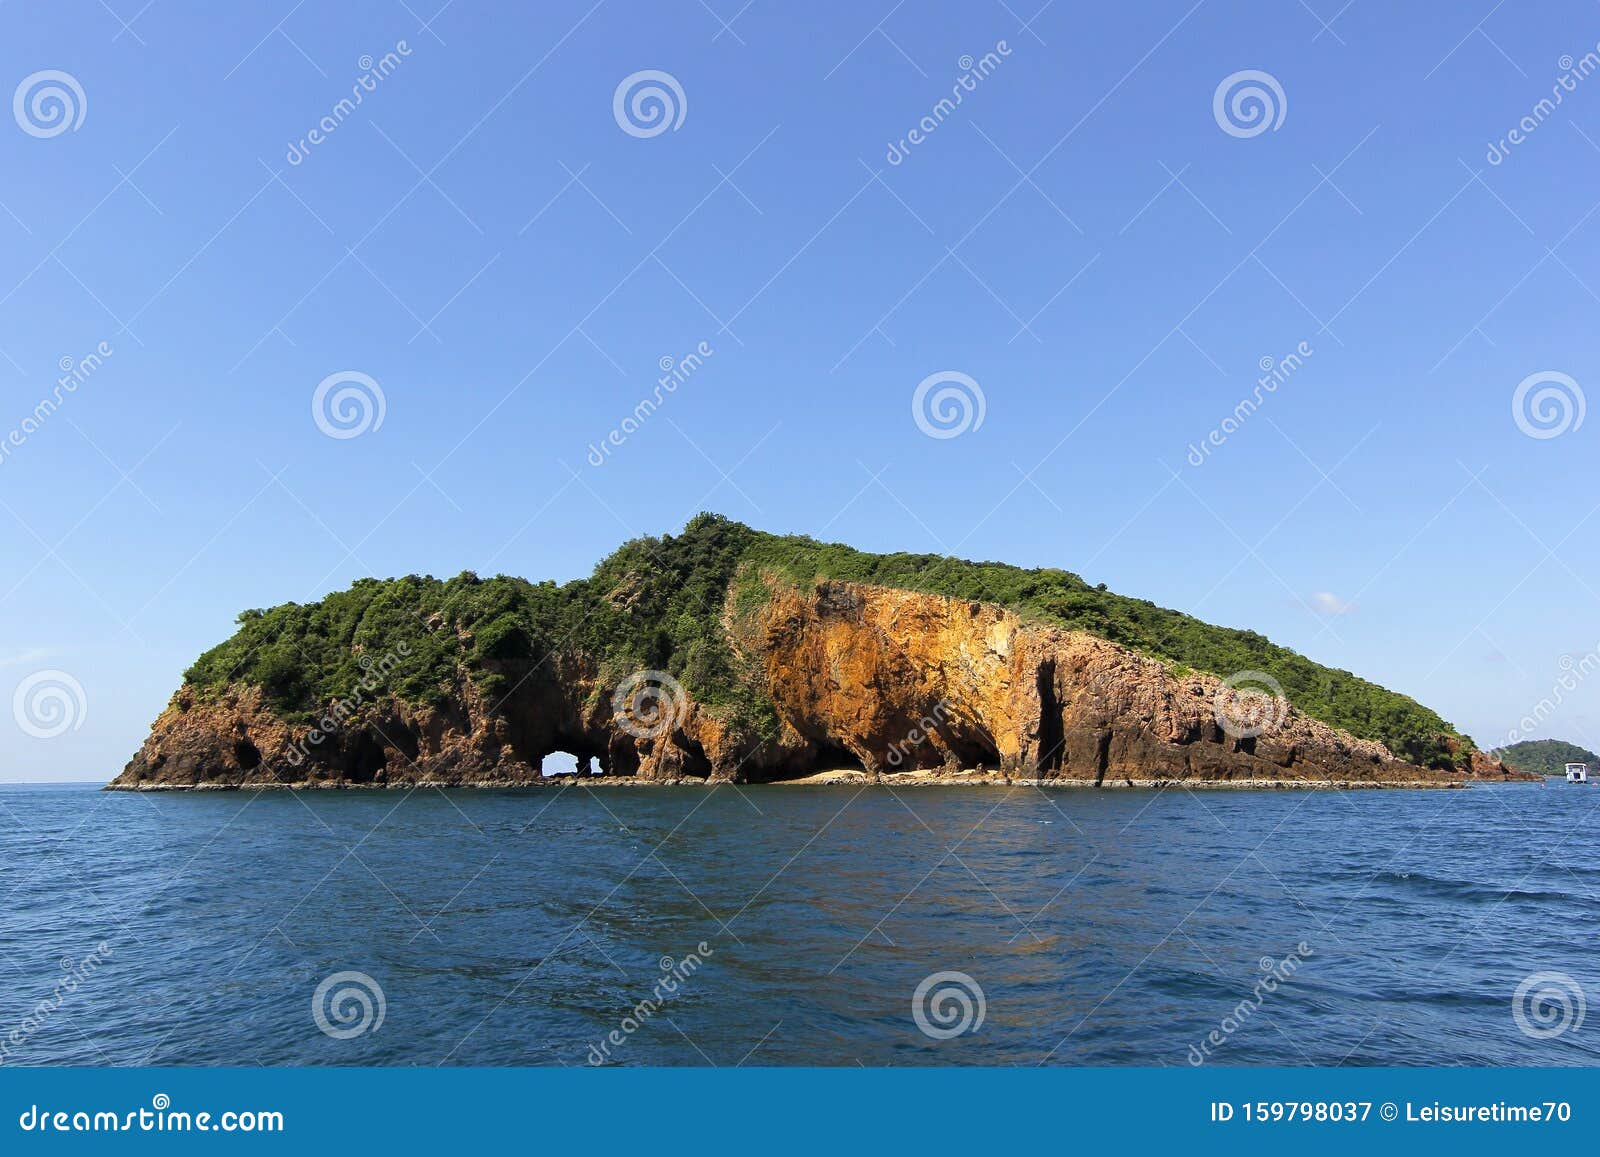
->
[0,0,1600,781]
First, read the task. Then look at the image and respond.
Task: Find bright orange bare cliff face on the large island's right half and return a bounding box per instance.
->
[732,583,1451,784]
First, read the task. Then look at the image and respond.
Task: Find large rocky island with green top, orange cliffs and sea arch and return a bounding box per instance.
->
[110,514,1531,789]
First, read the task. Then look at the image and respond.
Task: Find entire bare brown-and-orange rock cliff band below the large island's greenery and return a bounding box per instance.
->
[112,581,1465,787]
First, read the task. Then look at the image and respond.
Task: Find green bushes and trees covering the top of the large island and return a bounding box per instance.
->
[184,514,1474,767]
